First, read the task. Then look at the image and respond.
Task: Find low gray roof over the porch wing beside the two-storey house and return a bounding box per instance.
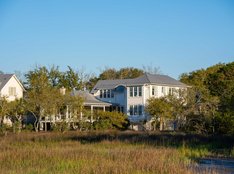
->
[72,91,111,106]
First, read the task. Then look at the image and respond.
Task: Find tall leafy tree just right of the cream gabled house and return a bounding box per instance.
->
[26,67,61,131]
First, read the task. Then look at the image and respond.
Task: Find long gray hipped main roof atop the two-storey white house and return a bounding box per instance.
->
[92,73,187,93]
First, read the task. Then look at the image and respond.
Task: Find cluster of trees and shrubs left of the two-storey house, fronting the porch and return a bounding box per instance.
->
[0,66,134,132]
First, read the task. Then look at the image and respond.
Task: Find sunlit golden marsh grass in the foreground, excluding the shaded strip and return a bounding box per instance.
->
[0,132,223,174]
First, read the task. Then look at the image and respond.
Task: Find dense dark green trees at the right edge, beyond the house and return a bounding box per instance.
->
[180,62,234,134]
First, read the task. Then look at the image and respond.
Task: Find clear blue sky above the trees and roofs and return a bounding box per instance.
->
[0,0,234,78]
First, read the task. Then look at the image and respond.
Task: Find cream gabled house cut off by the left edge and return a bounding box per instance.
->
[0,74,24,102]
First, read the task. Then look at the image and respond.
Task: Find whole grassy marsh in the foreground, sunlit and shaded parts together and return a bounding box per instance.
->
[0,131,233,174]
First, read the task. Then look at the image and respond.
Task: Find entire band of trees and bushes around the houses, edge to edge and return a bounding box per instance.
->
[0,62,234,134]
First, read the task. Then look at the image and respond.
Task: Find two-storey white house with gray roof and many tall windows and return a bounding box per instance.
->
[91,73,187,128]
